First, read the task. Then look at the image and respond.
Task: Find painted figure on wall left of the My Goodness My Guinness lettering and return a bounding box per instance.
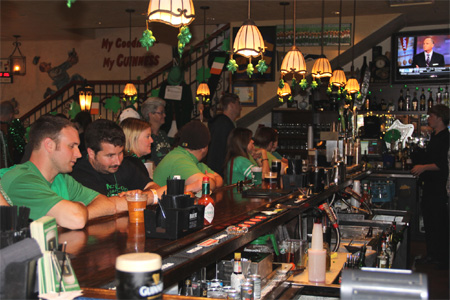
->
[39,49,84,99]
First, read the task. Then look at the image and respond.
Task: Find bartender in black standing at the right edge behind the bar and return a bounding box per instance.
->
[411,104,449,269]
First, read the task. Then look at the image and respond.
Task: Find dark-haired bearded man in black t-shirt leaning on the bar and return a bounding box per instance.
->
[71,119,166,203]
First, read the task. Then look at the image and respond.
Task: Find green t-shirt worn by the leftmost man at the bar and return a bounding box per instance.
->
[0,161,99,220]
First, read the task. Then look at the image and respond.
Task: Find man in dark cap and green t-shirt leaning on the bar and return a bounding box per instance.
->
[153,120,223,191]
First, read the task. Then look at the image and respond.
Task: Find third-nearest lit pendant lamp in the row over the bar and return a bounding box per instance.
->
[280,0,306,82]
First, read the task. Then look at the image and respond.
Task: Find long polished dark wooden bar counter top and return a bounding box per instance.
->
[58,171,370,298]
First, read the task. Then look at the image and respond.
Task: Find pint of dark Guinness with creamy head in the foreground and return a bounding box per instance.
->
[116,252,164,299]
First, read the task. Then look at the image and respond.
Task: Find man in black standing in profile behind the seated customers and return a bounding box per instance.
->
[206,93,242,177]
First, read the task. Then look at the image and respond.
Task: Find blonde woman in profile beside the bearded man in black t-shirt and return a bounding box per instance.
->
[120,118,153,176]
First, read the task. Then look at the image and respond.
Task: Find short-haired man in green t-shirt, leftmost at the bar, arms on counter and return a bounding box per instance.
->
[0,115,127,229]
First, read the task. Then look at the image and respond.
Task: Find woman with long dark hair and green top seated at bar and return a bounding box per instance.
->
[224,128,270,184]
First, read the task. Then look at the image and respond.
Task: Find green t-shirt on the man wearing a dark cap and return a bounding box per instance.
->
[153,146,215,186]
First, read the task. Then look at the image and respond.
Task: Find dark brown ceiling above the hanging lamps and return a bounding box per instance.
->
[0,0,450,42]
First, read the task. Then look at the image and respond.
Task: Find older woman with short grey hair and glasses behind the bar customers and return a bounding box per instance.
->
[141,97,171,167]
